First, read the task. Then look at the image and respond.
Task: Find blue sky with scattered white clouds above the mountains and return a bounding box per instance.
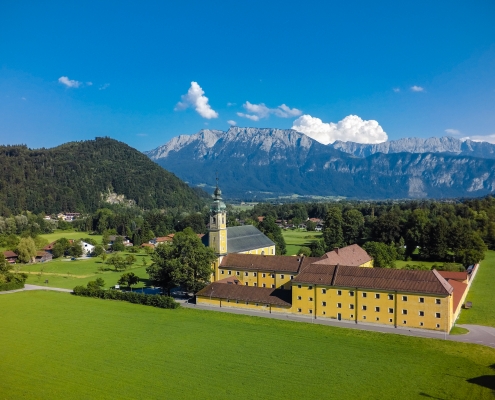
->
[0,0,495,150]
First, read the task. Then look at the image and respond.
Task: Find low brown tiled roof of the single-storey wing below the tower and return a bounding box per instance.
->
[196,282,291,307]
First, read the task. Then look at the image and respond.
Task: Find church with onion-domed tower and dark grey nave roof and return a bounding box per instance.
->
[202,186,275,282]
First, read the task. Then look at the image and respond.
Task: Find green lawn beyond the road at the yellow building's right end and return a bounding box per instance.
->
[457,251,495,327]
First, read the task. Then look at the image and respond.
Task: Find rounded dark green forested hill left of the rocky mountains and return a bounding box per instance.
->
[0,138,206,216]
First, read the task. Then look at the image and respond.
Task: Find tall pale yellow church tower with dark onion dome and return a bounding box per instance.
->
[208,182,227,281]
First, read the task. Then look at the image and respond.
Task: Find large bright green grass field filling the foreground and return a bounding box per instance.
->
[0,292,495,399]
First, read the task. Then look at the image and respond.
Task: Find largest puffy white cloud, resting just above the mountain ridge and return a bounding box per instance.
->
[292,115,388,144]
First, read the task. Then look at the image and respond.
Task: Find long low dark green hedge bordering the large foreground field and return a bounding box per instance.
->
[73,286,180,308]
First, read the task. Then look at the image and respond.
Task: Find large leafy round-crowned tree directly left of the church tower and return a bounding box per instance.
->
[146,228,216,295]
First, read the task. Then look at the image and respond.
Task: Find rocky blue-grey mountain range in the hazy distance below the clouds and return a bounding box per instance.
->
[145,127,495,199]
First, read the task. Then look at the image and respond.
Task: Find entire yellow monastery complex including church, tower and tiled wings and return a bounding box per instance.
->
[196,186,469,332]
